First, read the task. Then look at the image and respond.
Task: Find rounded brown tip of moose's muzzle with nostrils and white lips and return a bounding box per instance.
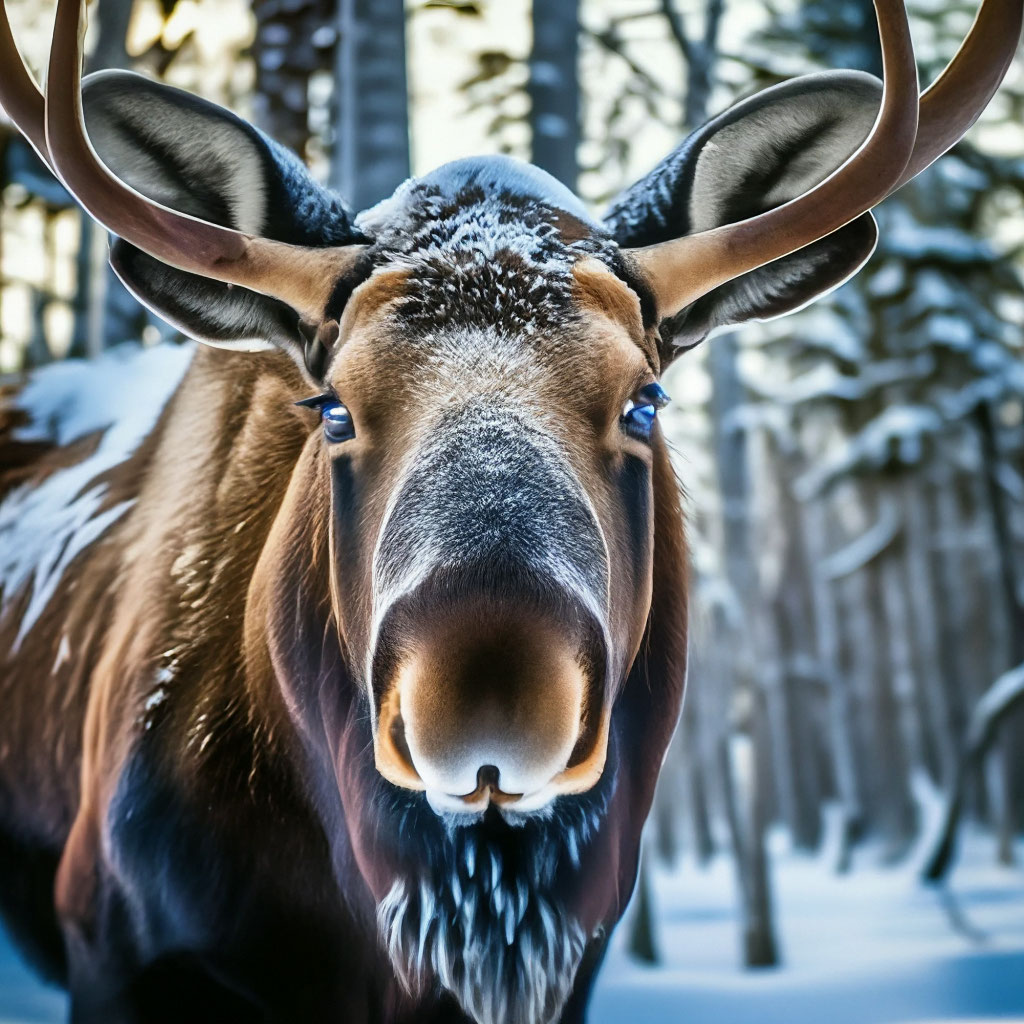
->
[375,600,607,814]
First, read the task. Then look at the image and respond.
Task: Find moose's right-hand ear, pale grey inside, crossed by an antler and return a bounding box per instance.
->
[604,72,882,360]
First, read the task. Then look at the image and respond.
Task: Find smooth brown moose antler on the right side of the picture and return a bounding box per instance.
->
[627,0,1024,317]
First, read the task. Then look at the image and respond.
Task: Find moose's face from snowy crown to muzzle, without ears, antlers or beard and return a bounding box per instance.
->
[311,161,666,815]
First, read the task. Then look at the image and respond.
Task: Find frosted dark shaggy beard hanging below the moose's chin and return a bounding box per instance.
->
[377,813,598,1024]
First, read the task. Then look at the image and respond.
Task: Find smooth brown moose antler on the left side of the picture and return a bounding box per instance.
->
[0,0,361,323]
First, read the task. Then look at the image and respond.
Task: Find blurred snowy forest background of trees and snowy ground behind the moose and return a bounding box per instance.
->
[0,0,1024,1024]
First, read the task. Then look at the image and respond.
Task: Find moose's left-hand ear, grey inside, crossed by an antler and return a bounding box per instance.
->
[82,71,366,362]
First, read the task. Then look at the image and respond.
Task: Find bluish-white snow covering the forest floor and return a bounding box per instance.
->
[0,833,1024,1024]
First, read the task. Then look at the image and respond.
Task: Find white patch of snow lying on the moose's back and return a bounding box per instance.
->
[0,345,193,648]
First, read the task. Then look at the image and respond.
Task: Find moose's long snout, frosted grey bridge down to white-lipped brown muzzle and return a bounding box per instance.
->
[370,407,610,813]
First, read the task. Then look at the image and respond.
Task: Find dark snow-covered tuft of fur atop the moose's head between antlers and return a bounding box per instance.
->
[357,157,620,335]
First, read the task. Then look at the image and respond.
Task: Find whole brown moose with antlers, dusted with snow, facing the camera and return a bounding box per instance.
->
[0,0,1024,1024]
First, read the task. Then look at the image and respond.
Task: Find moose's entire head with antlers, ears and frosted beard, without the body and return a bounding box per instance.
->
[0,0,1021,1022]
